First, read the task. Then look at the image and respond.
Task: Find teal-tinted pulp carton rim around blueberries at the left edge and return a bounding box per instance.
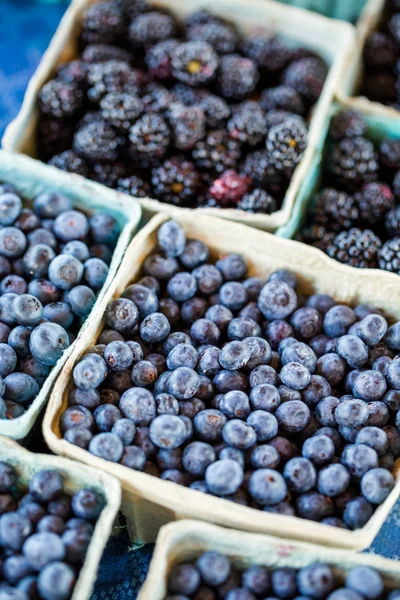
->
[0,150,141,440]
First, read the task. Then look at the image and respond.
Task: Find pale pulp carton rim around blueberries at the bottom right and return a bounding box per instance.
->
[138,521,400,600]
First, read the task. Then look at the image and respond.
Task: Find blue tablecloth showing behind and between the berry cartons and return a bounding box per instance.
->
[0,0,400,600]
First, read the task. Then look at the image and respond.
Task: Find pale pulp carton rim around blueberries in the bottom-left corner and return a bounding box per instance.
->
[0,436,121,600]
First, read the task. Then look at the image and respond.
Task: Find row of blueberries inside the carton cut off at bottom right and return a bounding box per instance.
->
[165,551,400,600]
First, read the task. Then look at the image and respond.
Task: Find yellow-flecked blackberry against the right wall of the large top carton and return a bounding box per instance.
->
[266,119,307,170]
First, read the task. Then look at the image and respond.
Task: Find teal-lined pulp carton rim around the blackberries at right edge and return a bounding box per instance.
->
[276,102,400,240]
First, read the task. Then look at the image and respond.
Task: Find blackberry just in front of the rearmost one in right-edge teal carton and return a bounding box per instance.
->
[328,136,379,190]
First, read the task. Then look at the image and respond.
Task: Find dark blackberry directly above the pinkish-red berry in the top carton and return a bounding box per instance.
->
[192,129,240,173]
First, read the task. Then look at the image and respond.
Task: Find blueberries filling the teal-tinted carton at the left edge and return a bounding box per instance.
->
[0,184,119,419]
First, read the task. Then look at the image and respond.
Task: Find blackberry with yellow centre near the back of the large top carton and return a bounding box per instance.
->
[171,41,218,86]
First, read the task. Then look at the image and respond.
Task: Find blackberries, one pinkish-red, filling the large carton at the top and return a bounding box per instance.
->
[37,0,327,214]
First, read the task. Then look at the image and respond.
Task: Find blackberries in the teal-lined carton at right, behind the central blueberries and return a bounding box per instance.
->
[298,110,400,274]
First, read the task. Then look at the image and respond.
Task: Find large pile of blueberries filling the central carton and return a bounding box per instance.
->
[60,221,400,529]
